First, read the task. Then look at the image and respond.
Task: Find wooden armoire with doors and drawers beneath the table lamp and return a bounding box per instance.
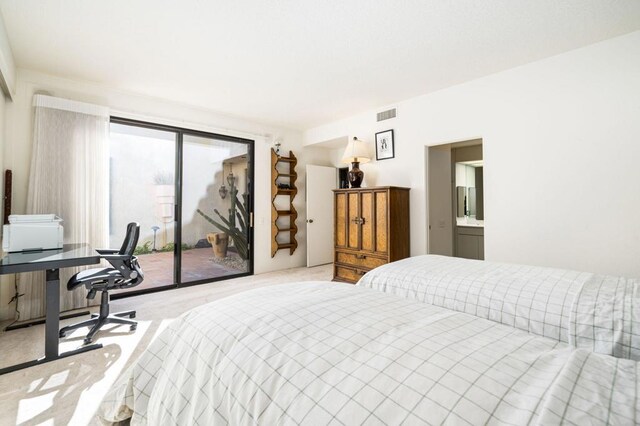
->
[333,186,410,283]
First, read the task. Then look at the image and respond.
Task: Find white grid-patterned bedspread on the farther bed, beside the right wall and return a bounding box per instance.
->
[358,255,640,360]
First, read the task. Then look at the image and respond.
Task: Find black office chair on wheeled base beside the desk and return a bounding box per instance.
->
[60,222,144,344]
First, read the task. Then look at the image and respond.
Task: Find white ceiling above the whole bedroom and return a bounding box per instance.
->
[0,0,640,129]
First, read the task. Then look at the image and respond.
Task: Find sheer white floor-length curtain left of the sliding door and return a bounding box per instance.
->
[18,95,109,320]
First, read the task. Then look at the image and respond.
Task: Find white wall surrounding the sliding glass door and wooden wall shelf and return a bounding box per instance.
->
[0,70,329,319]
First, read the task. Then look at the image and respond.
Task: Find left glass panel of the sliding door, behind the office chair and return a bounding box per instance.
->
[109,123,177,291]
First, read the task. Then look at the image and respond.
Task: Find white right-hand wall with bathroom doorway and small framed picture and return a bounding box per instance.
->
[304,31,640,276]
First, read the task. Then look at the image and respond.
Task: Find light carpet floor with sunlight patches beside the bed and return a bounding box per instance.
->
[0,265,332,425]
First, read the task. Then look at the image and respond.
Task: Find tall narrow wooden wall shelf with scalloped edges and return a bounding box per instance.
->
[271,149,298,257]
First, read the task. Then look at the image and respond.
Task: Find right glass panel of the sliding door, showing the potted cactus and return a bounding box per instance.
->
[180,134,251,283]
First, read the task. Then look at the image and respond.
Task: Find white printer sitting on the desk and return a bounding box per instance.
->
[2,214,64,252]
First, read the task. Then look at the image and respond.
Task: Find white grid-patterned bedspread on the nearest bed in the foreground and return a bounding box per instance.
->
[101,283,640,425]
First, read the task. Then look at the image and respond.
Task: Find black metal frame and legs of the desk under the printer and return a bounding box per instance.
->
[0,245,102,375]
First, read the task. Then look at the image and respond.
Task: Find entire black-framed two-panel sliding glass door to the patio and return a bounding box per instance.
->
[109,118,253,297]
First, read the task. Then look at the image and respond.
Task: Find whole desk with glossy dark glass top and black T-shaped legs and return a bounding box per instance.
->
[0,244,102,375]
